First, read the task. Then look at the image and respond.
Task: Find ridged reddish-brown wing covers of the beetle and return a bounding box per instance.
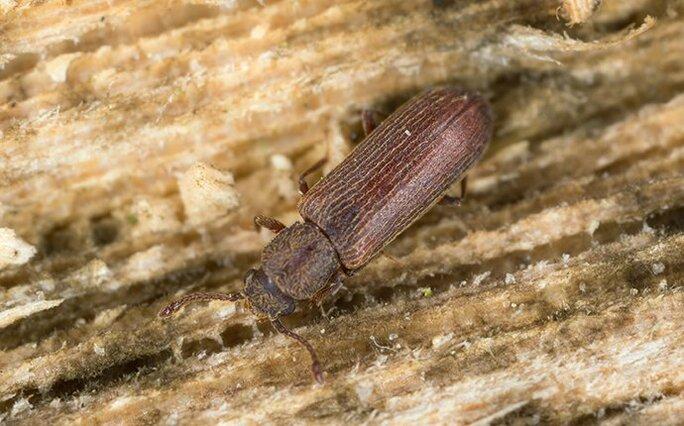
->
[299,88,492,270]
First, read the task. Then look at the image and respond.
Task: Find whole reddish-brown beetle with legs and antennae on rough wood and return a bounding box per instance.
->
[159,87,493,383]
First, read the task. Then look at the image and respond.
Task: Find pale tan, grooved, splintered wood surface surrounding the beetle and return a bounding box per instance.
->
[0,0,684,425]
